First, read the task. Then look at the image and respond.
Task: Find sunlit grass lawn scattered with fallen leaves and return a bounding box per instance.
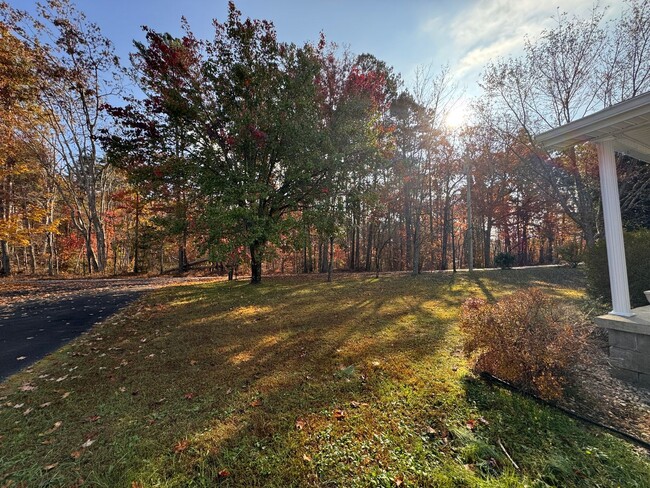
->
[0,268,650,488]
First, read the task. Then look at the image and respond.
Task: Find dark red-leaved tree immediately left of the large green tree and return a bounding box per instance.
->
[102,23,201,272]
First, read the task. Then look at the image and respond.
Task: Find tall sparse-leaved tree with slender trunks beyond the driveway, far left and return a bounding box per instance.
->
[3,0,121,271]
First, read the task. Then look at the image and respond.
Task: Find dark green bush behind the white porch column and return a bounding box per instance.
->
[586,229,650,307]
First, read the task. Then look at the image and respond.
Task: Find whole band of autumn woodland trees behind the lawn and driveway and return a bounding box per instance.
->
[0,0,650,282]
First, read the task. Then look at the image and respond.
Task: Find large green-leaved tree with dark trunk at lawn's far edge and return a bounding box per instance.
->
[200,3,330,283]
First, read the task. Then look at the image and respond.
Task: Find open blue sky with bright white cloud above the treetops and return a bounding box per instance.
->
[9,0,623,123]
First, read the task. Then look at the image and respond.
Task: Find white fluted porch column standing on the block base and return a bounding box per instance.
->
[596,138,634,317]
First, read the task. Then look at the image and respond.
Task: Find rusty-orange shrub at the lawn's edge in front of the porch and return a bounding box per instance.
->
[461,288,588,399]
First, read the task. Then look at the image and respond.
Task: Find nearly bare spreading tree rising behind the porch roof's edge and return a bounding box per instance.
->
[483,9,605,246]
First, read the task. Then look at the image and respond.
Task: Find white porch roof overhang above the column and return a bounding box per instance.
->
[535,92,650,161]
